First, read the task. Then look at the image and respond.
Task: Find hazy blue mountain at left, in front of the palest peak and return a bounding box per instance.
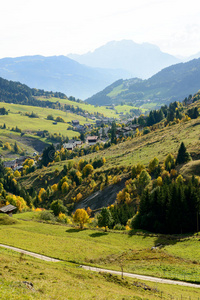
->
[0,55,130,99]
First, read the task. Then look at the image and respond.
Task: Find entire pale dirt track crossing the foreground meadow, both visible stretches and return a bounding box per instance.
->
[0,244,200,288]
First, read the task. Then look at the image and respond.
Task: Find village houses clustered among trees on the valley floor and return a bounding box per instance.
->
[1,113,143,172]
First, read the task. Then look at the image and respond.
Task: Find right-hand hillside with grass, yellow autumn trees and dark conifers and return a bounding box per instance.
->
[1,93,200,233]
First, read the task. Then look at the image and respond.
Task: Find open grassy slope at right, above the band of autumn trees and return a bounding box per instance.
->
[20,115,200,189]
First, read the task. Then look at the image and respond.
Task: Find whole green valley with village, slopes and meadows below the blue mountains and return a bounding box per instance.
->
[0,48,200,300]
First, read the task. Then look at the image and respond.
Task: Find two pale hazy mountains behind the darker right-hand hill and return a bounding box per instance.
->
[0,40,180,100]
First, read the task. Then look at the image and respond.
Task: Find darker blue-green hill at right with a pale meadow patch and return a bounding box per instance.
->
[87,59,200,106]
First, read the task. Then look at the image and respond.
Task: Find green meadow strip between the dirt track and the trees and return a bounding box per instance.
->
[0,214,200,282]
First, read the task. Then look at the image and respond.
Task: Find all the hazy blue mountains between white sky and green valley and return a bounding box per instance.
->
[0,40,199,105]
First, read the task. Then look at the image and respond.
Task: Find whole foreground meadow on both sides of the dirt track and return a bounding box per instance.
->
[0,213,200,300]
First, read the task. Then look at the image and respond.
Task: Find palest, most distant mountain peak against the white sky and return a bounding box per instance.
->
[68,40,180,79]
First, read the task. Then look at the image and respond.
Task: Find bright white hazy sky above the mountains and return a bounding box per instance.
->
[0,0,200,58]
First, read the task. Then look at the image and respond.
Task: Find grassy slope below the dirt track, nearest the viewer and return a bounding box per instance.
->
[0,248,198,300]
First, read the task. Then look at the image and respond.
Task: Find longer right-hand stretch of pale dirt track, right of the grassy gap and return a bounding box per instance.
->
[80,265,200,288]
